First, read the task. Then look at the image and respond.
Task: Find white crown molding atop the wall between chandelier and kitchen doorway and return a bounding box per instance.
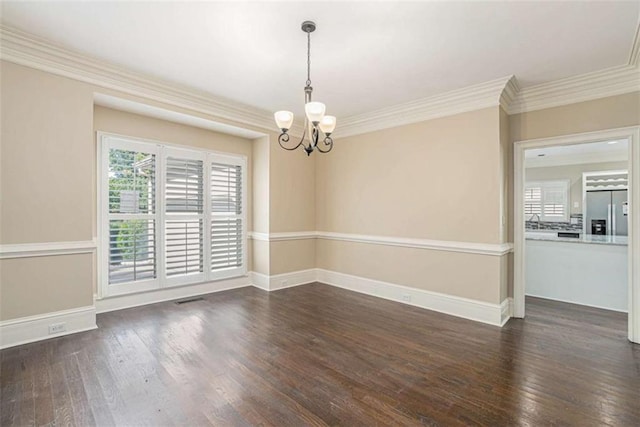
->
[336,76,517,138]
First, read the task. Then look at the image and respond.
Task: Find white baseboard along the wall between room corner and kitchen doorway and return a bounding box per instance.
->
[318,269,510,326]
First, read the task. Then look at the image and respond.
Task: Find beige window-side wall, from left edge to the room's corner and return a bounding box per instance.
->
[0,61,315,320]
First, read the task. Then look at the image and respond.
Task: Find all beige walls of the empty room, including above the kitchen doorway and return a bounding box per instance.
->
[0,55,640,320]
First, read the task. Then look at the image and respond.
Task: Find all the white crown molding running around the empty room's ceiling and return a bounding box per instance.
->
[0,25,640,138]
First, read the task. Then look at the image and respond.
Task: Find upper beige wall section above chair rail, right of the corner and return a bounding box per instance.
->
[316,107,502,243]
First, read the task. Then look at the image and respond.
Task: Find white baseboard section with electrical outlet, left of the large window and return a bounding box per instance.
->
[0,306,97,349]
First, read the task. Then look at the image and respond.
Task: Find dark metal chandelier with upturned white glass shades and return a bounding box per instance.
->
[274,21,336,156]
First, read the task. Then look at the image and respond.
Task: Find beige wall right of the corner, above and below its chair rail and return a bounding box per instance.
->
[316,107,506,304]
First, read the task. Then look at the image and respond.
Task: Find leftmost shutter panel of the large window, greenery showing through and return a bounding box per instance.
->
[100,138,158,294]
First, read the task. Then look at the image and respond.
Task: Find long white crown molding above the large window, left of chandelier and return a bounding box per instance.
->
[0,25,274,131]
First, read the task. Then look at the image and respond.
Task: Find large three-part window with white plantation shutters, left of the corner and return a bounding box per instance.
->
[100,135,247,296]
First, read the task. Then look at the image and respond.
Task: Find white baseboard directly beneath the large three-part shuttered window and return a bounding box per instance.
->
[95,276,251,313]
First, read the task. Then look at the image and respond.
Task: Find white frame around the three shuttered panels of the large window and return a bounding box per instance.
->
[96,131,248,298]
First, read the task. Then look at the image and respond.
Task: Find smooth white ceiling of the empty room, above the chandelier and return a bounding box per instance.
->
[1,1,640,120]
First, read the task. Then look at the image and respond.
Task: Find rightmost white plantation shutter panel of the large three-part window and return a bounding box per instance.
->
[210,162,244,272]
